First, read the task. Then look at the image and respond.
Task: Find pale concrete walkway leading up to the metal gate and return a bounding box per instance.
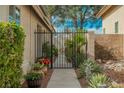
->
[47,69,81,88]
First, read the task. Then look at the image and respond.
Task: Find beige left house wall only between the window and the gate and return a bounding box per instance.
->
[19,6,48,74]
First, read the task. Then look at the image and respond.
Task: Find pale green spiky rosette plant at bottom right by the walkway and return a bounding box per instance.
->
[89,74,110,88]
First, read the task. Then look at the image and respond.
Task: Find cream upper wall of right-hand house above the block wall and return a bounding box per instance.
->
[102,6,124,34]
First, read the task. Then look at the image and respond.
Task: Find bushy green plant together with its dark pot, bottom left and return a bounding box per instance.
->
[25,72,43,88]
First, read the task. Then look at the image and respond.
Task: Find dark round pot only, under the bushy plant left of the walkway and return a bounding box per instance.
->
[27,78,42,88]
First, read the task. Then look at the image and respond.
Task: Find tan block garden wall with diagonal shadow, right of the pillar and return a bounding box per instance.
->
[95,34,124,60]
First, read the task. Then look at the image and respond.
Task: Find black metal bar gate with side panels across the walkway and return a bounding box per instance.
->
[35,32,87,68]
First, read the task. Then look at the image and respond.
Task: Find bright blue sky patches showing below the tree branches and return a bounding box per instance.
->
[55,18,102,34]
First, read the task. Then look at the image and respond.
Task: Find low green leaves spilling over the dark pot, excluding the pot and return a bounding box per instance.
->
[25,72,43,80]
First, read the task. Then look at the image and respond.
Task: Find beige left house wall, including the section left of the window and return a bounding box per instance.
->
[0,5,50,77]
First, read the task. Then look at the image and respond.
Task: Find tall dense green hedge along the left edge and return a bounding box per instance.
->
[0,22,25,88]
